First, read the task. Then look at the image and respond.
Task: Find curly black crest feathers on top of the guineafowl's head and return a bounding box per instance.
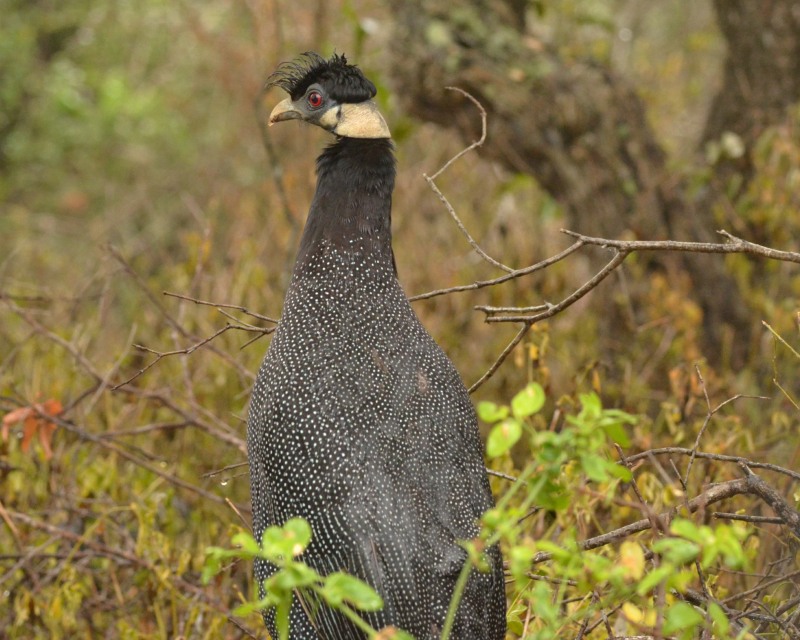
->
[267,51,378,103]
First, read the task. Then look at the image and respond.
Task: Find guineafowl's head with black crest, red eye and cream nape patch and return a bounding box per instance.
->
[267,52,391,138]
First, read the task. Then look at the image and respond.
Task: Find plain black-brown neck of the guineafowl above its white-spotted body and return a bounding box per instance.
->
[295,138,395,269]
